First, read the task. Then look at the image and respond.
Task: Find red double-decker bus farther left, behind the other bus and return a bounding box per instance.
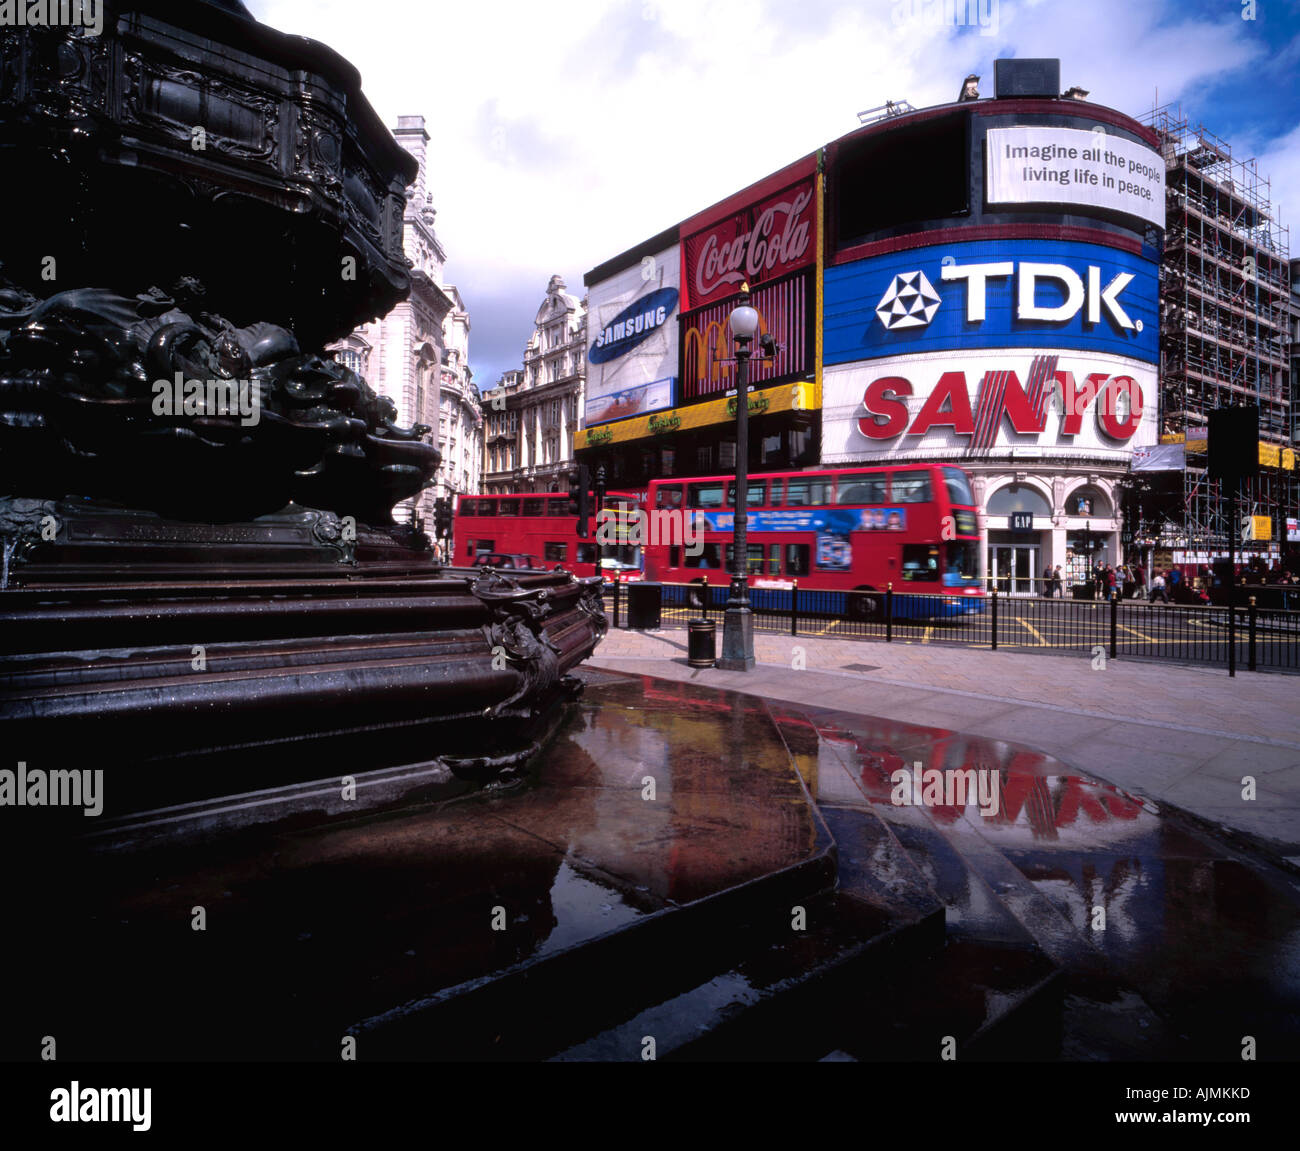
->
[451,492,641,581]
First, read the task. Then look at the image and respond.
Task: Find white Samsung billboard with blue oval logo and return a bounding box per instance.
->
[582,245,681,427]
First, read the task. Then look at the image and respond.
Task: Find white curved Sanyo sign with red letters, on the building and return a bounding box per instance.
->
[823,350,1156,463]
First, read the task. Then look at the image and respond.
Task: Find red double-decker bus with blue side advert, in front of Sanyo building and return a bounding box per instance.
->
[645,463,984,618]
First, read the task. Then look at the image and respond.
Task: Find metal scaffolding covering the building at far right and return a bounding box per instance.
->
[1138,105,1296,553]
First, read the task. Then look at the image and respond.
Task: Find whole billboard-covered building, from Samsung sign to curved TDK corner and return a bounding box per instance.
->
[576,60,1165,593]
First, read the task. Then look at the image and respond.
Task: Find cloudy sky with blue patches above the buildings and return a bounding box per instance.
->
[246,0,1300,388]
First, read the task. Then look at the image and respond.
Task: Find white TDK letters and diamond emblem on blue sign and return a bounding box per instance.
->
[876,260,1143,332]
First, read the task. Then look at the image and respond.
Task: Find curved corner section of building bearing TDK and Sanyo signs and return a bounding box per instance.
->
[822,61,1165,593]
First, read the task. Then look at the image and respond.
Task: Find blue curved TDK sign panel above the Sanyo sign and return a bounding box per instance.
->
[823,239,1160,364]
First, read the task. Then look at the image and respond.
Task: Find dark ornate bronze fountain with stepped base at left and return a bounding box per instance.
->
[0,0,606,806]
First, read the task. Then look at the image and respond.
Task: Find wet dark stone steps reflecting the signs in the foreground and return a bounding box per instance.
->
[5,670,1300,1061]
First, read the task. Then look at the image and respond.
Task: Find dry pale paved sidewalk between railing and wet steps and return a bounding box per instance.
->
[586,628,1300,865]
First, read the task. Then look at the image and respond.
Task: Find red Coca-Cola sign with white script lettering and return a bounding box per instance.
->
[684,178,816,307]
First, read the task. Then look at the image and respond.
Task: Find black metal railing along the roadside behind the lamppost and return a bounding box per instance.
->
[606,580,1300,671]
